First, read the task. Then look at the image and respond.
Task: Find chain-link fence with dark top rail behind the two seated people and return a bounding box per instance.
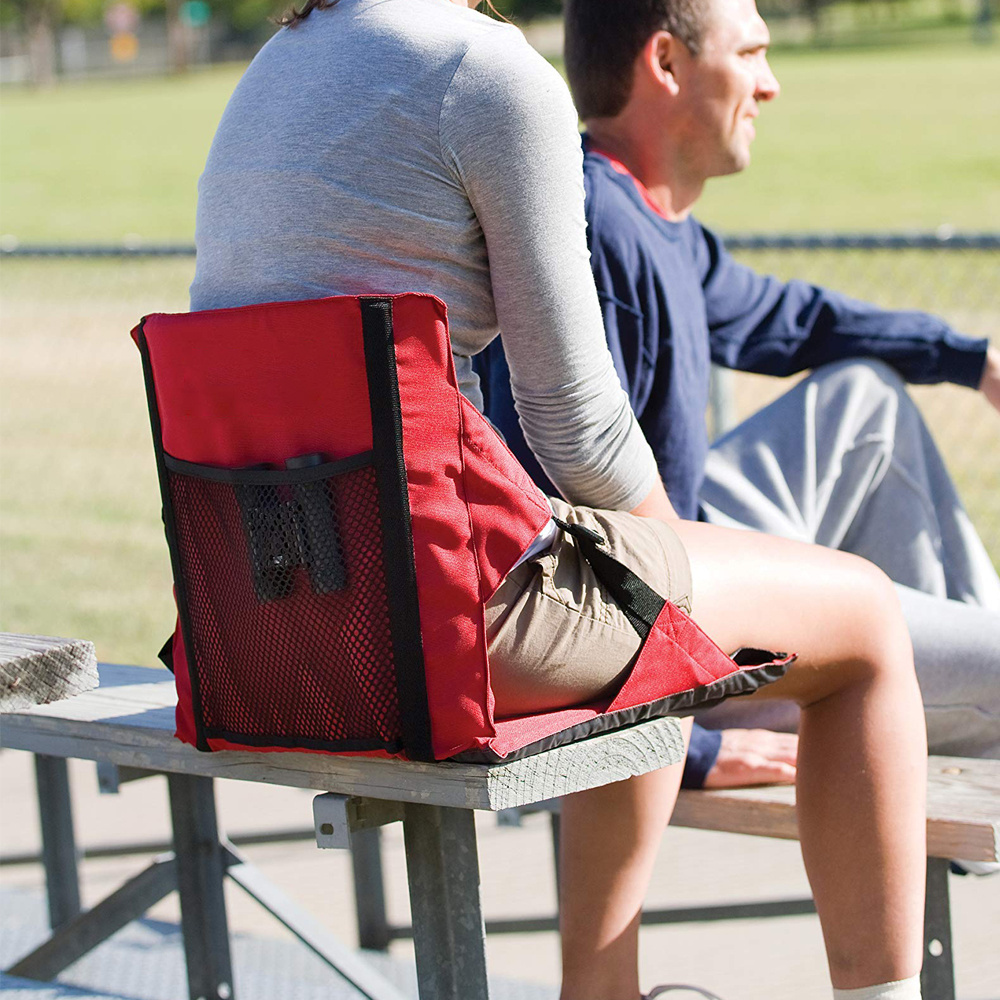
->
[0,234,1000,664]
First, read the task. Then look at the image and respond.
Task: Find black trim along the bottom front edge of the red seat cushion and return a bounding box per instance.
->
[449,656,795,764]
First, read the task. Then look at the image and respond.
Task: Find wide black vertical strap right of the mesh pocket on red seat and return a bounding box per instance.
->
[361,296,434,760]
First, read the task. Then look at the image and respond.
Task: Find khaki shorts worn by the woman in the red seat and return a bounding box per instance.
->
[486,499,691,717]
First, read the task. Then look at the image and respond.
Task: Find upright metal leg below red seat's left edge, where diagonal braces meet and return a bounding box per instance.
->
[167,774,233,1000]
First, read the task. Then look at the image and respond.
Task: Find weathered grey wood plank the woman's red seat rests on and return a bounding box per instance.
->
[0,664,683,810]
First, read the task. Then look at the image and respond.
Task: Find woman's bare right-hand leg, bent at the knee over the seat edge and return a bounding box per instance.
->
[677,523,927,989]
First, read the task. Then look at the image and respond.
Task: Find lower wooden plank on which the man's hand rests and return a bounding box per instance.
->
[671,757,1000,861]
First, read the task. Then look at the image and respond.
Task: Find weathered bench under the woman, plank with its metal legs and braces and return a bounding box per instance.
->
[0,664,683,1000]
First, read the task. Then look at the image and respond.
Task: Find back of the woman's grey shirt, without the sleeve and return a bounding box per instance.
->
[191,0,508,340]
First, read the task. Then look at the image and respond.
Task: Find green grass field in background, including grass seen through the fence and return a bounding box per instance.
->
[0,45,1000,664]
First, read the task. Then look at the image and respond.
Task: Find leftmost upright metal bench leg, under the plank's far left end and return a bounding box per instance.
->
[35,754,80,930]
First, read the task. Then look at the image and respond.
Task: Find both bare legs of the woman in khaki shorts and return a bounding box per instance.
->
[562,522,926,1000]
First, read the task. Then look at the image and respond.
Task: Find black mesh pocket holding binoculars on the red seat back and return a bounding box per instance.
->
[169,467,400,749]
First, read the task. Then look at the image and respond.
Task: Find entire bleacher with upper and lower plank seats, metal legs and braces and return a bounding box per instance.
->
[0,665,1000,1000]
